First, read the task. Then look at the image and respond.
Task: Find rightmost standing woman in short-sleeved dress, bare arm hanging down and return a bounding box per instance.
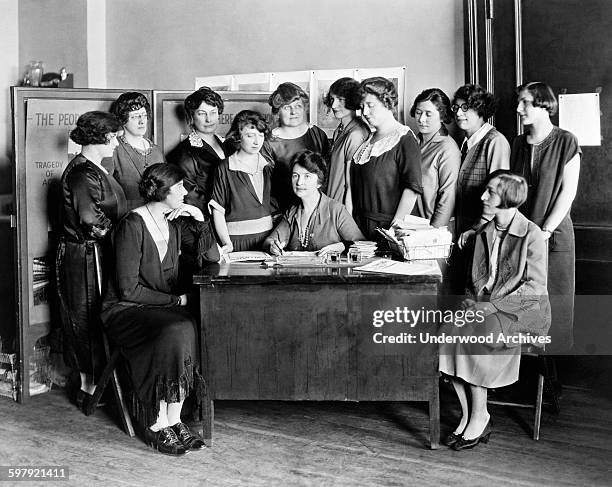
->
[511,82,582,352]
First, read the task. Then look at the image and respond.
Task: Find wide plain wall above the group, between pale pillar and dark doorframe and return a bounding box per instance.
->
[106,0,464,98]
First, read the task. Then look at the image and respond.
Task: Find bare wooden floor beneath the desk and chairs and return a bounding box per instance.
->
[0,389,612,486]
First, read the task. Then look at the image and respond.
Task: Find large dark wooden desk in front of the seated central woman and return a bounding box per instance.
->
[194,264,441,448]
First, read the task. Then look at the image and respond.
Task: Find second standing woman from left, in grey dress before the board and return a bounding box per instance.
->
[110,91,165,210]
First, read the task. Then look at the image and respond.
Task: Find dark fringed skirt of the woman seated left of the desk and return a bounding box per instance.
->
[106,305,204,426]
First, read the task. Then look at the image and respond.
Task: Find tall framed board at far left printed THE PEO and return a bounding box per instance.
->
[11,87,152,401]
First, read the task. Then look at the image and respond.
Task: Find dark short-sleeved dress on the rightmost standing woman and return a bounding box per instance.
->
[510,127,582,353]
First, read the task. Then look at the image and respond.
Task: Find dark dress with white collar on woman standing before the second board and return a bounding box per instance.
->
[166,133,229,215]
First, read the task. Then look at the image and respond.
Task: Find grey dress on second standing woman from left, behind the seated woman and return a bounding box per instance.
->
[103,136,166,211]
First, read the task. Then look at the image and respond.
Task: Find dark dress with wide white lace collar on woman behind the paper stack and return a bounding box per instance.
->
[351,125,423,241]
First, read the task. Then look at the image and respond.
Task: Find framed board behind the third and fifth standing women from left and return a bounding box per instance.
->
[153,91,272,154]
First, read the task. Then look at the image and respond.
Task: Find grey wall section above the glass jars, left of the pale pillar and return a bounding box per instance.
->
[19,0,88,88]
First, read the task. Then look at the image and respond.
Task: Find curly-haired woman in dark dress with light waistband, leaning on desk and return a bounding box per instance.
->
[209,110,273,254]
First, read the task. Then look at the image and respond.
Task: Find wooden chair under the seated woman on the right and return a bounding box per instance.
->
[488,345,559,440]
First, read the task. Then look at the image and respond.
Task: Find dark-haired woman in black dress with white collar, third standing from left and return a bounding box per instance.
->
[168,86,229,214]
